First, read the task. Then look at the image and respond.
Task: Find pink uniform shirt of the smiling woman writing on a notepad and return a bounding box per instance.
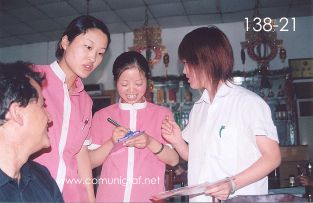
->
[90,102,172,202]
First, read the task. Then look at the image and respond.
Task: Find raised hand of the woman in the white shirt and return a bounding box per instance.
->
[161,116,183,146]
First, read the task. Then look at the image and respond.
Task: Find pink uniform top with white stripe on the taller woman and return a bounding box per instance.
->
[34,61,92,202]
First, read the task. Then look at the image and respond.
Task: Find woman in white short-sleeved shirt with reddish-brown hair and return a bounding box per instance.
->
[162,27,281,202]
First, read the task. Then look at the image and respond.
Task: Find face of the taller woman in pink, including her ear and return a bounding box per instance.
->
[59,28,108,78]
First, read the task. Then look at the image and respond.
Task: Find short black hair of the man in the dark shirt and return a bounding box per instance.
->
[0,61,44,125]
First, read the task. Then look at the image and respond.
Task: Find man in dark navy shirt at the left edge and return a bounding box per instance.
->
[0,62,63,202]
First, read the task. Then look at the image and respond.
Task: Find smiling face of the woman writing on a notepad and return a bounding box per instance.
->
[116,65,147,104]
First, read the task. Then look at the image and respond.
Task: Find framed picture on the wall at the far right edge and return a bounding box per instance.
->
[288,58,313,78]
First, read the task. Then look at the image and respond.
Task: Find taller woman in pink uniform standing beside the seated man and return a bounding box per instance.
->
[34,16,110,202]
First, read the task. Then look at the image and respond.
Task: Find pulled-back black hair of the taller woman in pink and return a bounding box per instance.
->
[55,15,111,60]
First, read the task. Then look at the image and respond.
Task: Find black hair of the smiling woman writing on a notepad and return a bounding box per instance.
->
[112,51,151,82]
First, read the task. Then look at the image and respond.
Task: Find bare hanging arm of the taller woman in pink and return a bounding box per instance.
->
[76,145,96,202]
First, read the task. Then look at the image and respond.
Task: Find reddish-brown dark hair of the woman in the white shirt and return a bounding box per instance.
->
[178,26,234,95]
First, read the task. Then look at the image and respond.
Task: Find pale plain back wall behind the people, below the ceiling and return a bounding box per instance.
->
[0,16,313,89]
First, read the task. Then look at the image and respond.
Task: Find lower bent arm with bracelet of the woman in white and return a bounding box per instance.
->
[206,136,281,200]
